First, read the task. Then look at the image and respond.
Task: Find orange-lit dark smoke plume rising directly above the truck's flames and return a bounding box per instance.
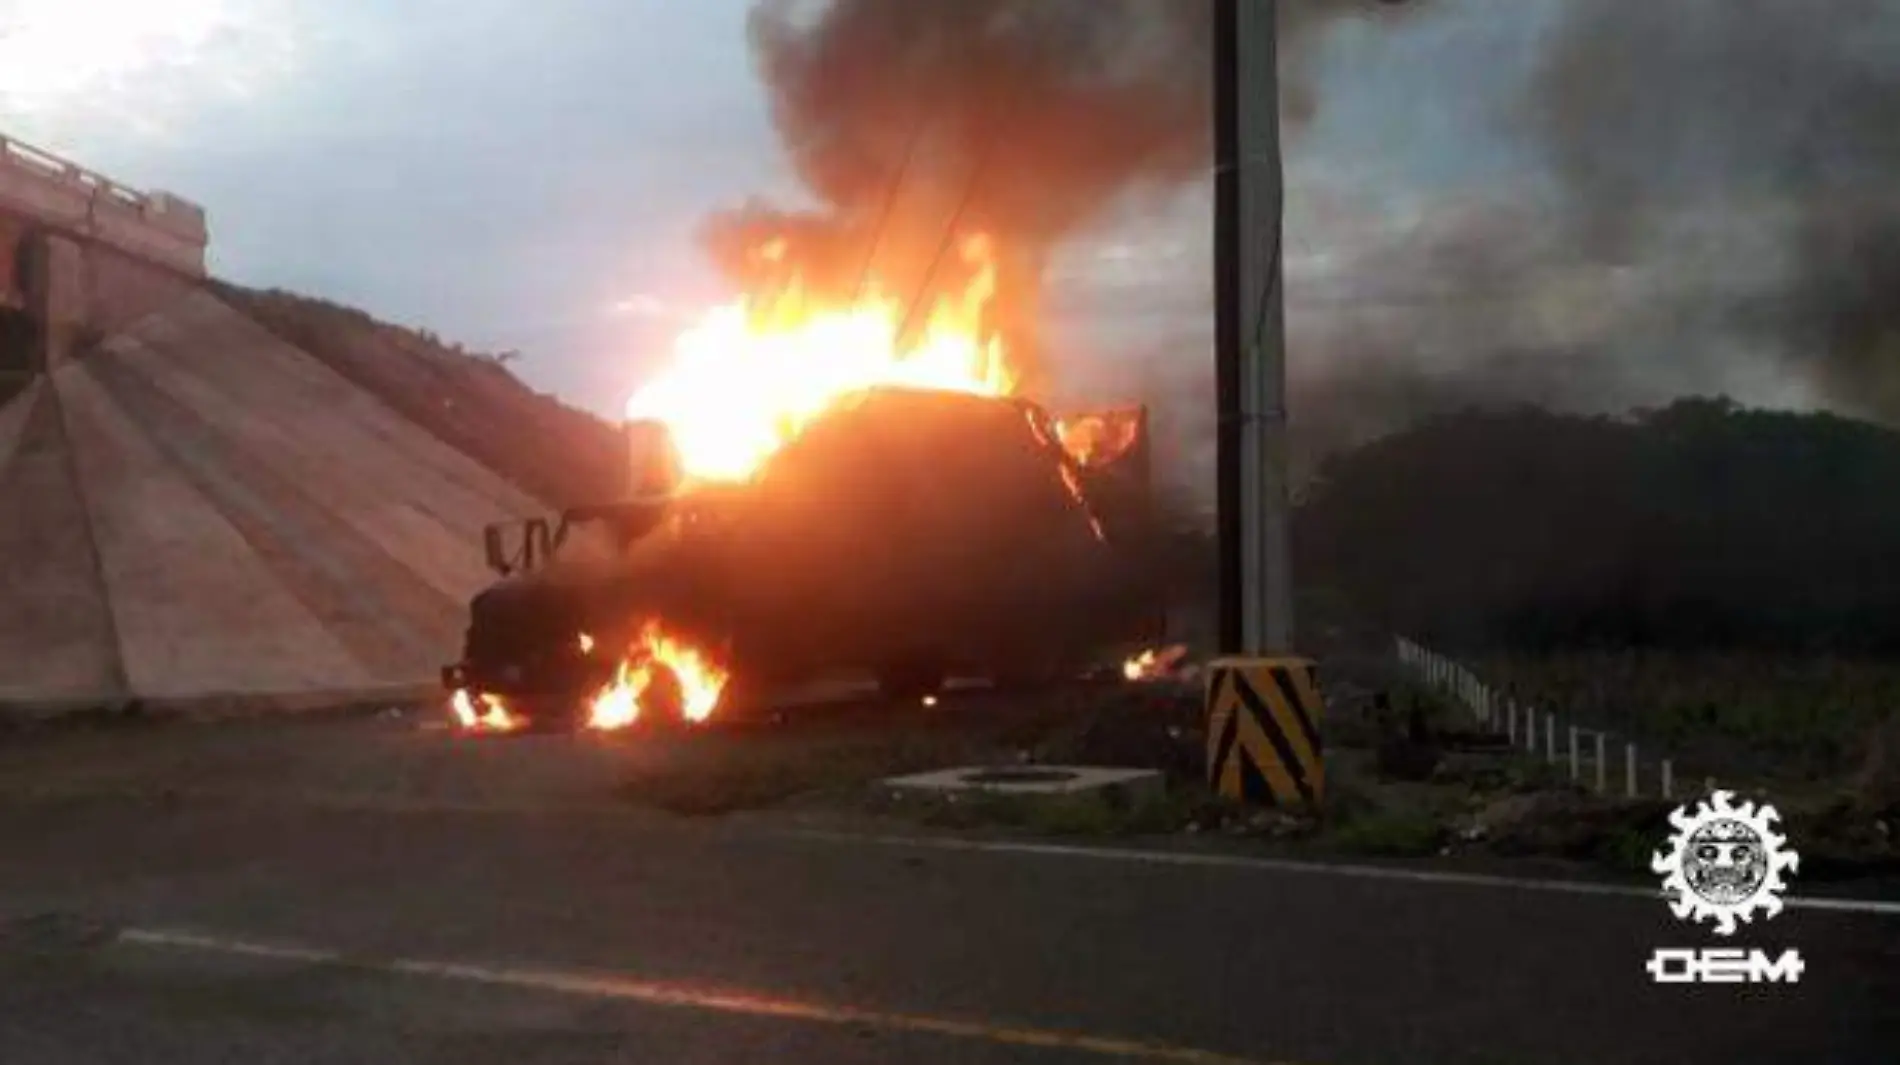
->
[705,0,1413,389]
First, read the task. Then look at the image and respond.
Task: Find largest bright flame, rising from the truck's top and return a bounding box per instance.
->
[627,235,1017,482]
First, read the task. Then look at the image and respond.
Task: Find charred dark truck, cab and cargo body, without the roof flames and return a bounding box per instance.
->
[443,389,1161,718]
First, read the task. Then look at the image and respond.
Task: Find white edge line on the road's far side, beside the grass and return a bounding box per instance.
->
[773,830,1900,917]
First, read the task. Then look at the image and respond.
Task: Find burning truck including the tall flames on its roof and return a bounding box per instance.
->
[443,232,1163,731]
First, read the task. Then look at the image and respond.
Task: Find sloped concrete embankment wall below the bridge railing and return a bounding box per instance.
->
[0,282,558,710]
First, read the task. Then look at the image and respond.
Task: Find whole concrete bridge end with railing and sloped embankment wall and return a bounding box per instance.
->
[0,139,562,714]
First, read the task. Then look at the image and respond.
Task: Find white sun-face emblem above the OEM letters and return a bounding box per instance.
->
[1649,792,1801,936]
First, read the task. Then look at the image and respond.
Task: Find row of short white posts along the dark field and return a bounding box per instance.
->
[1397,636,1676,799]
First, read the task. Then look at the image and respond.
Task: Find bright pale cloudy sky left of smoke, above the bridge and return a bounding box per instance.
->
[0,0,787,423]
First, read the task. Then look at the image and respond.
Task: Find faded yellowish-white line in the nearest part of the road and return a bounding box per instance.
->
[118,928,1290,1065]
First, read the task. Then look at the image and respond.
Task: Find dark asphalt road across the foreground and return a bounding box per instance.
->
[0,713,1900,1065]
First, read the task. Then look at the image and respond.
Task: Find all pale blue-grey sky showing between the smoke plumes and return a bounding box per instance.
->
[0,0,1839,482]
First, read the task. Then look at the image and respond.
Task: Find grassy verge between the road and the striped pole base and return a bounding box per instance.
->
[600,656,1900,875]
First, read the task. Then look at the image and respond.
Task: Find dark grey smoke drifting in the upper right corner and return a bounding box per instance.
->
[1526,0,1900,420]
